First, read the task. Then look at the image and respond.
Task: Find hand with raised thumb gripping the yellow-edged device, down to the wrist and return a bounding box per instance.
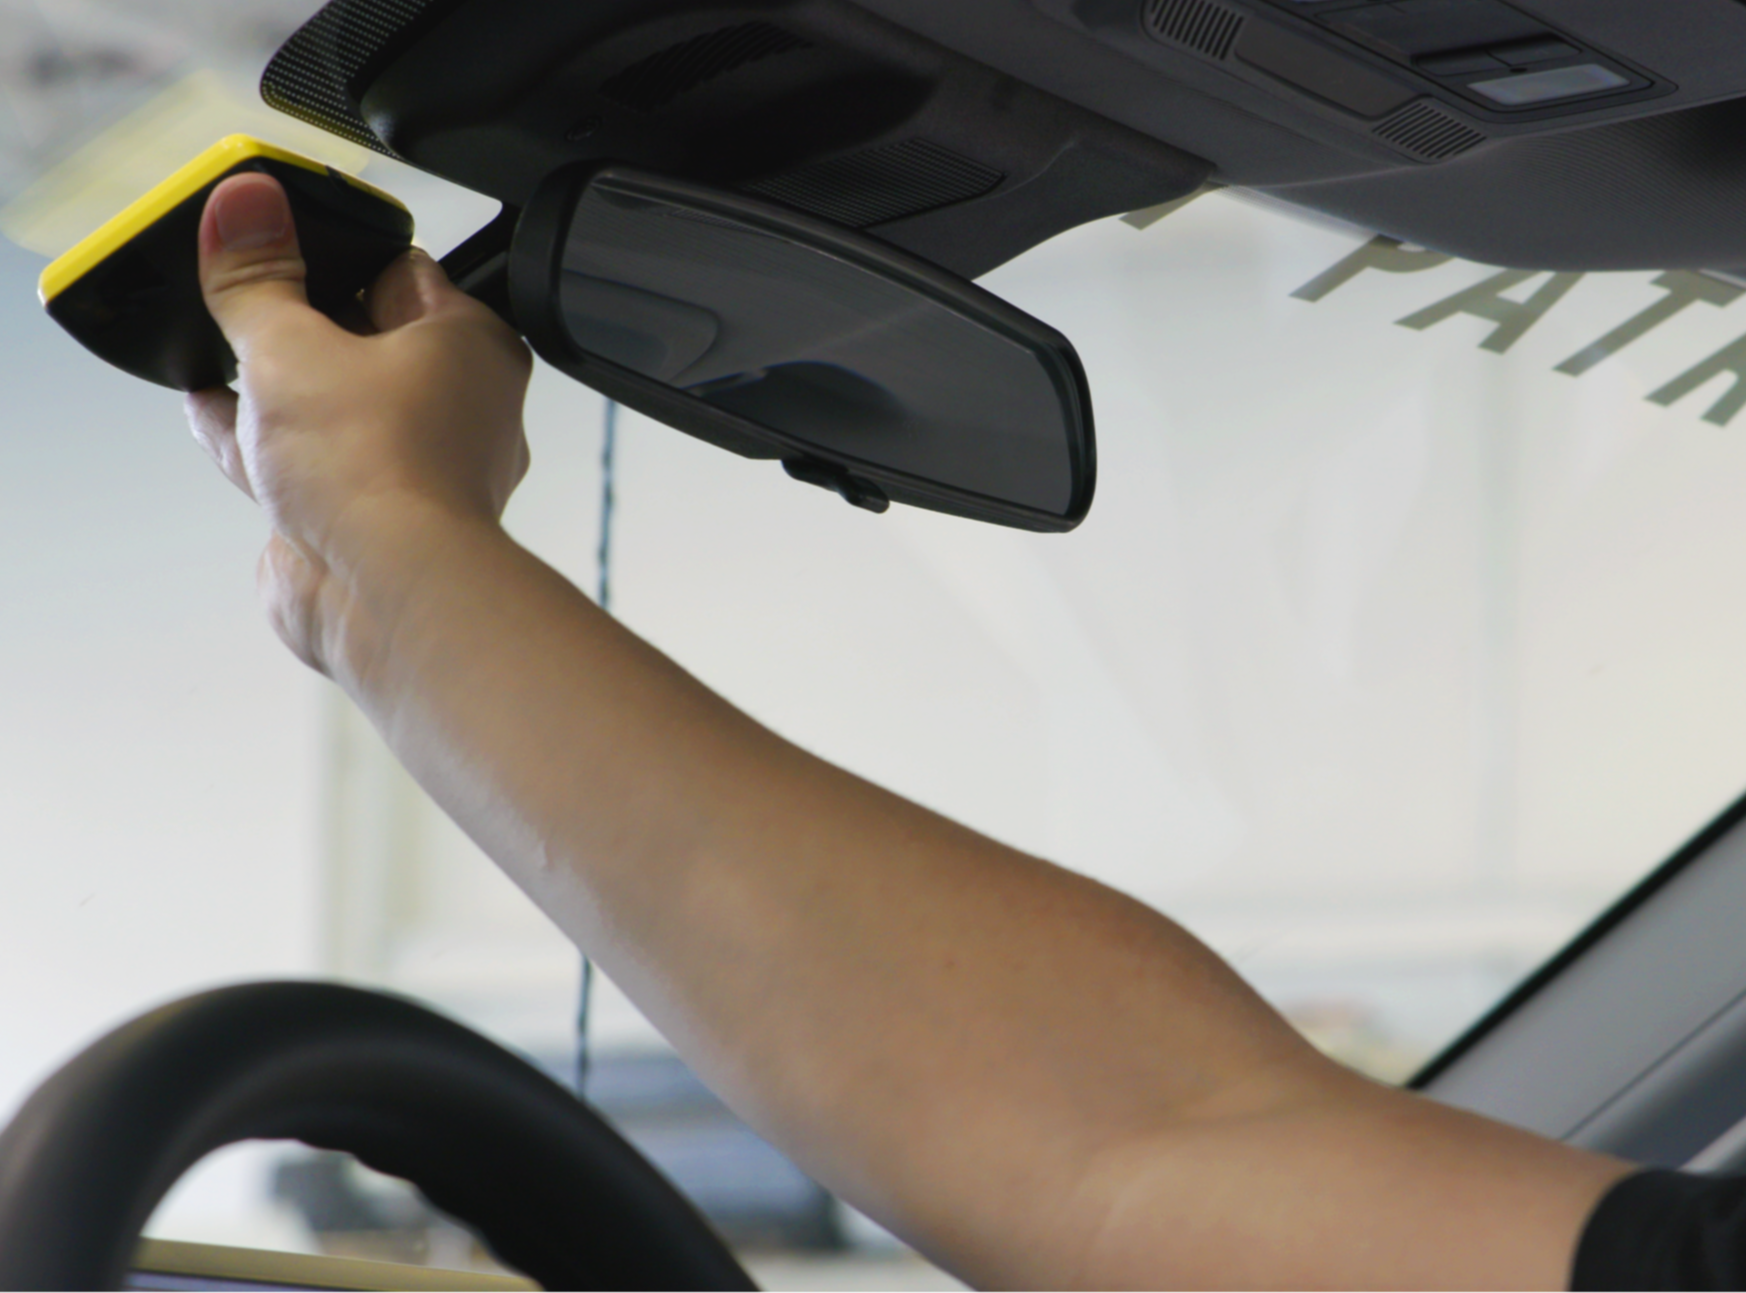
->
[187,174,533,675]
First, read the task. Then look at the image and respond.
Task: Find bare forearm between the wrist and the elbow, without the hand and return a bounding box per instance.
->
[321,506,1306,1284]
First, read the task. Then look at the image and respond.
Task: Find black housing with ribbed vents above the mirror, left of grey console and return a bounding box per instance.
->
[264,0,1212,277]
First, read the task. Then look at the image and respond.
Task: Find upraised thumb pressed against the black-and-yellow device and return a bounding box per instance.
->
[201,174,328,363]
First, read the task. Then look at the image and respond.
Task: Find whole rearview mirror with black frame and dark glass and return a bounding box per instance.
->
[510,166,1095,530]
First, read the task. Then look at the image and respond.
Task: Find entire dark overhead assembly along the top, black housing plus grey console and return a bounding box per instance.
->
[267,0,1746,276]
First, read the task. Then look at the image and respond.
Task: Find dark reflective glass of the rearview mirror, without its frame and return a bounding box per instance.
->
[559,180,1081,515]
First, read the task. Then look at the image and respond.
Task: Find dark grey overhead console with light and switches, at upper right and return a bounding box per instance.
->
[834,0,1746,270]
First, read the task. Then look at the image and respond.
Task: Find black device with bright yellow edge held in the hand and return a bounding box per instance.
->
[40,134,412,391]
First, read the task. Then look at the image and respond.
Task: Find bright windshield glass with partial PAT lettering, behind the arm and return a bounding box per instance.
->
[10,0,1746,1284]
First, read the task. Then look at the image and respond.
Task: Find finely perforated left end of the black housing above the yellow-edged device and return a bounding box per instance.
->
[260,0,456,157]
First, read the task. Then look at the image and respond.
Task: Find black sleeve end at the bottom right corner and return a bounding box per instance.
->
[1571,1171,1746,1293]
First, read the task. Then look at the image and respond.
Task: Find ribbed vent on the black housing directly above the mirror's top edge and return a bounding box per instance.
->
[746,140,1006,229]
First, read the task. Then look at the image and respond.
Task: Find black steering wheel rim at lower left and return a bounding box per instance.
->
[0,982,771,1293]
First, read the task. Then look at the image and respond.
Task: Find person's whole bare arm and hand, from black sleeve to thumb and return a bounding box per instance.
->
[189,176,1631,1293]
